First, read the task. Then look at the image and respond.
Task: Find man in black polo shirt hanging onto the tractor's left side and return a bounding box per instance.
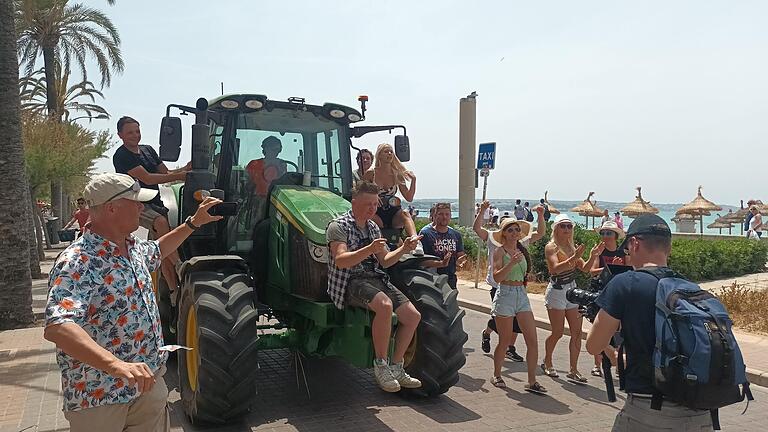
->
[112,116,191,304]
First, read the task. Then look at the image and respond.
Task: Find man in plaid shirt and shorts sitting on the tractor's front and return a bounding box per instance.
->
[326,181,421,392]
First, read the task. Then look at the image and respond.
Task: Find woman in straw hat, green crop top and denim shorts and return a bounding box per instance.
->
[491,218,547,393]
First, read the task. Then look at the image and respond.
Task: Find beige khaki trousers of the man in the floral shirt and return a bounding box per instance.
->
[64,366,171,432]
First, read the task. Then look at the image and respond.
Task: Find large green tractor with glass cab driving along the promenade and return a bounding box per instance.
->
[157,94,467,423]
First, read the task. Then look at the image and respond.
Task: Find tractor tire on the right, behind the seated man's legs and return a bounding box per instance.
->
[393,270,468,396]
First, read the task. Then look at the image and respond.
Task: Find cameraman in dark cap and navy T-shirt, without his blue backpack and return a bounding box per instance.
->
[587,215,712,431]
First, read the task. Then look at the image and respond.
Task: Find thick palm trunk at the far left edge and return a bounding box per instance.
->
[0,0,33,329]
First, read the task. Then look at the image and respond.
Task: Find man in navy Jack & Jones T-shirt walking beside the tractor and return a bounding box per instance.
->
[419,203,467,289]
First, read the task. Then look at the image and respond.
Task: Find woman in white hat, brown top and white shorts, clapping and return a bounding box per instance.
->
[541,213,605,383]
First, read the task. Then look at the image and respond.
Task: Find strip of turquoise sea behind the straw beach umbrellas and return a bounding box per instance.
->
[412,198,740,235]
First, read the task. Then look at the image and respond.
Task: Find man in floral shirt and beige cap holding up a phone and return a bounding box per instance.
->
[45,174,221,432]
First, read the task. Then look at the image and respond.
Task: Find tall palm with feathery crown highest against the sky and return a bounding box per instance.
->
[16,0,125,118]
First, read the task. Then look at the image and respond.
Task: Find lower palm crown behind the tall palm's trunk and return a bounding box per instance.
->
[19,68,109,121]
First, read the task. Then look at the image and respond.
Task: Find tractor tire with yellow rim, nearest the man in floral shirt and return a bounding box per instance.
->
[176,271,259,423]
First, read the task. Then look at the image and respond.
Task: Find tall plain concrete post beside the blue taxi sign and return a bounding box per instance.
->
[459,92,477,226]
